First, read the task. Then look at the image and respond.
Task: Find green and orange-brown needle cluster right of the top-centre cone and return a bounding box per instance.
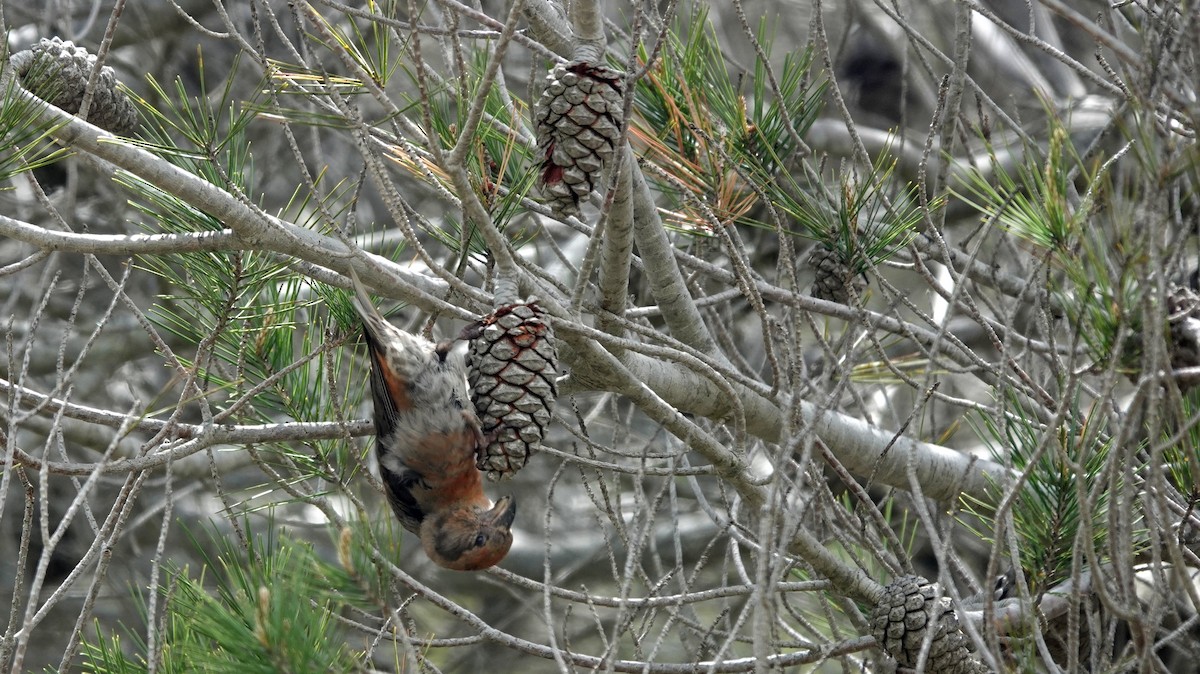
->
[630,7,824,234]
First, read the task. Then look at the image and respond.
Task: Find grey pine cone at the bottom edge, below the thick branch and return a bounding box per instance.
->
[868,576,991,674]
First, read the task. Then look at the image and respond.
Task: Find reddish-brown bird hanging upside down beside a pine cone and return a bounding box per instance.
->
[350,271,516,571]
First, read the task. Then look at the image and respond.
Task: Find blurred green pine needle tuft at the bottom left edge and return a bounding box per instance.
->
[80,520,364,674]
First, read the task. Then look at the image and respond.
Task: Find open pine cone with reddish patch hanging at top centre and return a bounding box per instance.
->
[534,61,624,217]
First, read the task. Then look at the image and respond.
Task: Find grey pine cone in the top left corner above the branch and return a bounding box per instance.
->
[12,37,138,136]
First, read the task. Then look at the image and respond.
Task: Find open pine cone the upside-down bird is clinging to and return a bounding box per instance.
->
[462,302,558,481]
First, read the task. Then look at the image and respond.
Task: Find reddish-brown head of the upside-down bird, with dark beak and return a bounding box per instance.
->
[421,497,517,571]
